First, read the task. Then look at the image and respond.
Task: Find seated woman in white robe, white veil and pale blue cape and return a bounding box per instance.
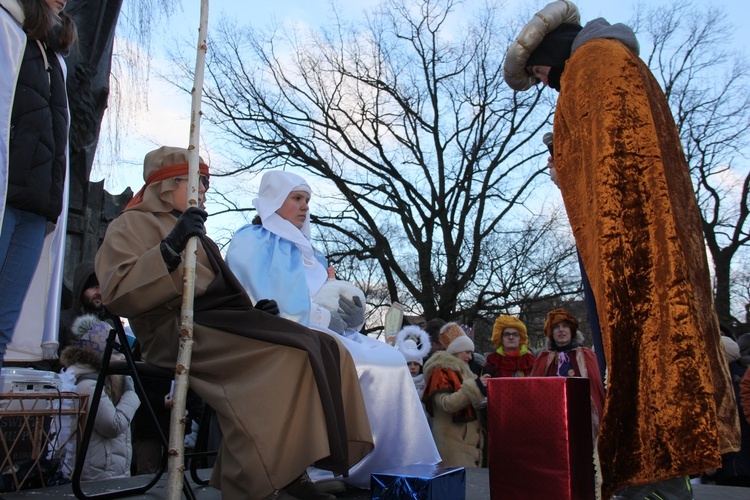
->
[226,171,440,488]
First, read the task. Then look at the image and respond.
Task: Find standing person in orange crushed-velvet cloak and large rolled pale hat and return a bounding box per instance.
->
[504,0,739,498]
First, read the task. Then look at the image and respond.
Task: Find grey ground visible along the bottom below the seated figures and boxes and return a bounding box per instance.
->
[1,469,750,500]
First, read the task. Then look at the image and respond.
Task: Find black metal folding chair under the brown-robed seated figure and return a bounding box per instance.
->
[72,311,216,500]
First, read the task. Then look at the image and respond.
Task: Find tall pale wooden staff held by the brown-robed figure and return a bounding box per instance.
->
[167,0,208,500]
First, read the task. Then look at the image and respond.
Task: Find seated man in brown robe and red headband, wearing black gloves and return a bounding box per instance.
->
[96,147,373,499]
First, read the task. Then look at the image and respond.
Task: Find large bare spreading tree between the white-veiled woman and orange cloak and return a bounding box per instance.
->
[181,0,578,319]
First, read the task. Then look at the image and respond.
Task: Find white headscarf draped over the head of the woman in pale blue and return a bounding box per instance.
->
[253,170,315,265]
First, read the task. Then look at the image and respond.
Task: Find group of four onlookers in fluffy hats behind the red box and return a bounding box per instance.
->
[396,309,604,467]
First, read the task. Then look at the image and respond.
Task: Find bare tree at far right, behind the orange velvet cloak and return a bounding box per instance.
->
[636,1,750,326]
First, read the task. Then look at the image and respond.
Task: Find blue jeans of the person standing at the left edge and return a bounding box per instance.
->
[0,205,47,368]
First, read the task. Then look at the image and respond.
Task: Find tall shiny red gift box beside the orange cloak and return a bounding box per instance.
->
[487,377,595,500]
